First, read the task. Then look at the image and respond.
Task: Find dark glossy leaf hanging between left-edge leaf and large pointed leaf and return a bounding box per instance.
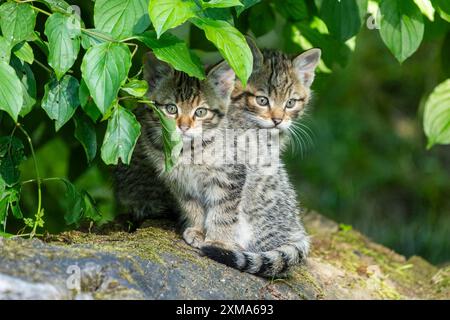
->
[42,75,80,131]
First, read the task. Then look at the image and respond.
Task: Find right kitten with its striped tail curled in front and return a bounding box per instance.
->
[201,41,321,277]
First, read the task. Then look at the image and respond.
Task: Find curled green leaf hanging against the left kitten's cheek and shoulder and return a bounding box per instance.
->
[150,104,183,172]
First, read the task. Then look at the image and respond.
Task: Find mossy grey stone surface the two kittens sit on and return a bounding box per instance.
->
[0,212,450,299]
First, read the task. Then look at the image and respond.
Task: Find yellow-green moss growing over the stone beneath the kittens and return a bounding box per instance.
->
[0,212,450,299]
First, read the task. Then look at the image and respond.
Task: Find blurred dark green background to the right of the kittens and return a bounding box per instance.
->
[286,26,450,263]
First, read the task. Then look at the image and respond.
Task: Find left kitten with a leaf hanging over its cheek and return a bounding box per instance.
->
[116,54,235,242]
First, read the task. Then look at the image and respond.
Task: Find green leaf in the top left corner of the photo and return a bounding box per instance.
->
[0,2,36,46]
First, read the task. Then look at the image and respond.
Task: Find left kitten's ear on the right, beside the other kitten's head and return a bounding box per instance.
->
[207,61,236,99]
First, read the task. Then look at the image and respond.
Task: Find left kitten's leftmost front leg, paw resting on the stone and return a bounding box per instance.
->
[181,199,205,248]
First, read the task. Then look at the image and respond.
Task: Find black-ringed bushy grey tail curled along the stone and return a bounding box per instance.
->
[201,238,309,277]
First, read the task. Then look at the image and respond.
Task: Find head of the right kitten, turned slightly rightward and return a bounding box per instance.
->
[233,48,320,131]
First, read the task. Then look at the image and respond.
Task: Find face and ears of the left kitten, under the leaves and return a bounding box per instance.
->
[144,53,235,140]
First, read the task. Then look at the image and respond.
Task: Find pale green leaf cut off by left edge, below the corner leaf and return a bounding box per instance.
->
[0,61,23,122]
